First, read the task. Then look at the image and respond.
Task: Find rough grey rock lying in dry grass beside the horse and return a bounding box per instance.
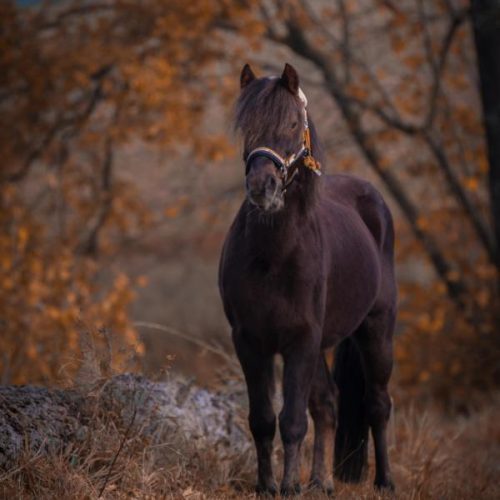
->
[0,374,250,469]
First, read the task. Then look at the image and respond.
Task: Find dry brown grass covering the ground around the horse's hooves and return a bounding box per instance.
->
[0,376,500,500]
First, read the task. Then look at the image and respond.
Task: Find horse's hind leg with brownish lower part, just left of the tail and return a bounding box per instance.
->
[309,355,336,494]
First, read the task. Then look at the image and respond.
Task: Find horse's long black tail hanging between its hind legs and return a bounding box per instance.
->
[333,337,368,483]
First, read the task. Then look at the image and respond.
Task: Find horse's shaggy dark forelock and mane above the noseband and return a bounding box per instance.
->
[234,78,323,163]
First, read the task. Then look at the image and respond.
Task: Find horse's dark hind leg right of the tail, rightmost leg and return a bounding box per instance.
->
[355,308,395,490]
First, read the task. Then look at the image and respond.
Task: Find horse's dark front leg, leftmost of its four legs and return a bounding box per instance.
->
[233,336,278,496]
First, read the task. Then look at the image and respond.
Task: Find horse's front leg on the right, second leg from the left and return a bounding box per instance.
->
[279,332,321,496]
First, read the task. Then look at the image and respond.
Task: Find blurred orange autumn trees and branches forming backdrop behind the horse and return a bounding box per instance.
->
[0,0,500,408]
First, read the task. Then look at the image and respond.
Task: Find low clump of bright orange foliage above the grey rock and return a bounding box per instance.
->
[0,186,143,383]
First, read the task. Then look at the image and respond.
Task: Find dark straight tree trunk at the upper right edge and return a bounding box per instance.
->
[471,0,500,274]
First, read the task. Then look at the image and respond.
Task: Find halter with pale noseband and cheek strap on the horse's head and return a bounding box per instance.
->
[245,88,321,192]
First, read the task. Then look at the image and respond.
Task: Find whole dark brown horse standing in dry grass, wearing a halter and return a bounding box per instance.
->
[219,64,396,495]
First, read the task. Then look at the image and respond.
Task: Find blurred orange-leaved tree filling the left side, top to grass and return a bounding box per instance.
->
[0,0,244,382]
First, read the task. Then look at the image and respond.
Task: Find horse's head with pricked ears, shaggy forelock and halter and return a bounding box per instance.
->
[236,64,308,212]
